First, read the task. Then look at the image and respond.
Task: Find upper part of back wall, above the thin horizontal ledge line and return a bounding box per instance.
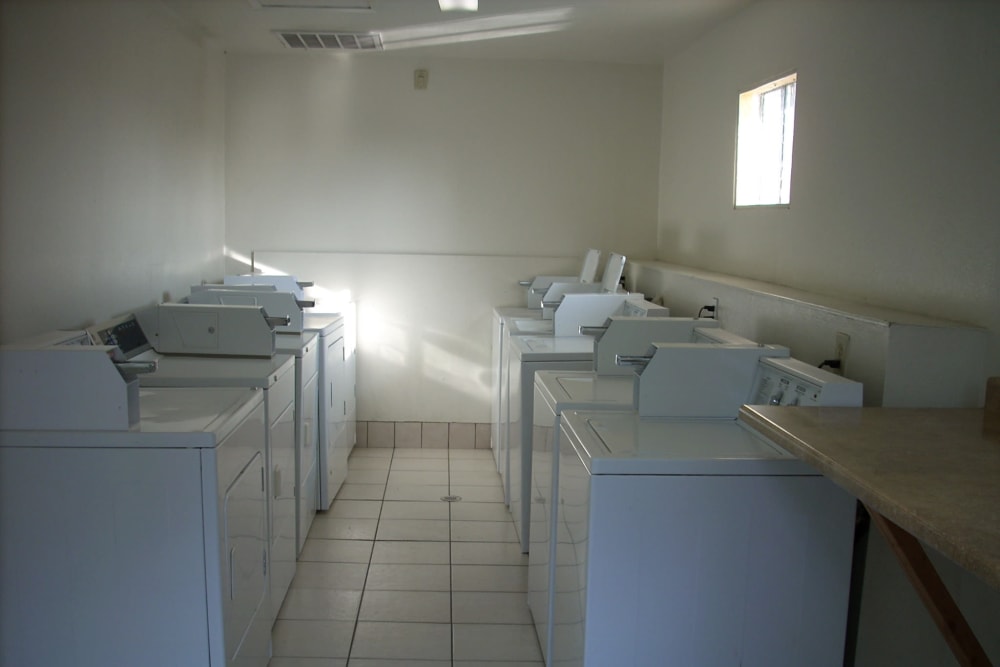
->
[226,54,660,256]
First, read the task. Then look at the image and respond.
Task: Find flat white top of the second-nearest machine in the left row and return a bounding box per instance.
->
[136,354,295,389]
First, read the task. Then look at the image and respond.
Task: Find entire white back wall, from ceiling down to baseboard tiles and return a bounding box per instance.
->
[226,54,660,422]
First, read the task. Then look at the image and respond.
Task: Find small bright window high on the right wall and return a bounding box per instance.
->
[735,74,795,206]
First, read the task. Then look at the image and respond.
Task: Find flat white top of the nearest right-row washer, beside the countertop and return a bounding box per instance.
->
[563,411,819,476]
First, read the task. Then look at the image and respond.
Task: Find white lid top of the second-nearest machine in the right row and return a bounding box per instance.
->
[535,371,635,412]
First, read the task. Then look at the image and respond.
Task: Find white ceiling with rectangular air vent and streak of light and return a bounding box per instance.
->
[162,0,753,64]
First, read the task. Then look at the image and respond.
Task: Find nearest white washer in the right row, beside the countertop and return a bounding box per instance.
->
[543,352,861,667]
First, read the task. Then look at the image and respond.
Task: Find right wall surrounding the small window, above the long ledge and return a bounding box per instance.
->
[658,0,1000,375]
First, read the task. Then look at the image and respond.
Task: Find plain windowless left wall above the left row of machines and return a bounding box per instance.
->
[0,0,225,342]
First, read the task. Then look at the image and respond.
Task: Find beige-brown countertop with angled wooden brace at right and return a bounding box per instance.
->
[739,406,1000,589]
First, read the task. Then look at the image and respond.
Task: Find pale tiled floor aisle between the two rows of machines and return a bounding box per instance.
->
[269,447,542,667]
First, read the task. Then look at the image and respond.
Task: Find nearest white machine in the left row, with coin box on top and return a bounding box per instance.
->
[0,346,271,667]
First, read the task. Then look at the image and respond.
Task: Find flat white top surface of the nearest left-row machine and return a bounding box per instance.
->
[0,387,264,449]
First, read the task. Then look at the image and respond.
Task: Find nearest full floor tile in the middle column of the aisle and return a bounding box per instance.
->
[351,621,451,660]
